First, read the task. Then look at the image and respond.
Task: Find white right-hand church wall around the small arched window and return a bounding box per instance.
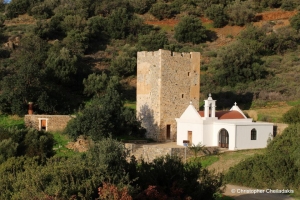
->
[236,123,273,149]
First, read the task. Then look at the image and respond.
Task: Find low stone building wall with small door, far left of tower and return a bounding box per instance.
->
[24,115,75,131]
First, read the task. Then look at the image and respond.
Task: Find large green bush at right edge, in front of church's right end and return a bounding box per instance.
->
[225,124,300,190]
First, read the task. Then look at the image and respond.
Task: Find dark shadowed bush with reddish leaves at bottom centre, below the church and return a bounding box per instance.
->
[134,155,223,199]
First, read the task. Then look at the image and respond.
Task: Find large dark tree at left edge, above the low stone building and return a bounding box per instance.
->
[0,36,48,115]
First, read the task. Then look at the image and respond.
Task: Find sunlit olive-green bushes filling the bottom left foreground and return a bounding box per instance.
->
[0,138,132,199]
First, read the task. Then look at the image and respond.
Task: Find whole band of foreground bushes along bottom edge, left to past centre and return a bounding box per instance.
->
[0,134,223,199]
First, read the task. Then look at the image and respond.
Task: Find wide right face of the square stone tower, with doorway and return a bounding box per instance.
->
[160,51,200,141]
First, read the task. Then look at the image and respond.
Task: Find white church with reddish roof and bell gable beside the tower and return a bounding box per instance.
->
[176,95,273,150]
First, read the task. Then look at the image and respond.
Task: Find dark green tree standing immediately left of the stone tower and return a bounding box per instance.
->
[65,77,145,141]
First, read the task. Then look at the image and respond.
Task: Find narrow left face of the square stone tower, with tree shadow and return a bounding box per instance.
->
[136,51,160,139]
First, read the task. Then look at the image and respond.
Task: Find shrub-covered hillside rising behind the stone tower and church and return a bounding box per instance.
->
[0,0,300,115]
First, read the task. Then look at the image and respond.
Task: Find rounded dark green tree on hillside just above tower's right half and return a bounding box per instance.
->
[174,16,207,44]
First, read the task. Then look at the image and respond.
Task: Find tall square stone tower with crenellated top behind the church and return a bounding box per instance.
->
[136,49,200,141]
